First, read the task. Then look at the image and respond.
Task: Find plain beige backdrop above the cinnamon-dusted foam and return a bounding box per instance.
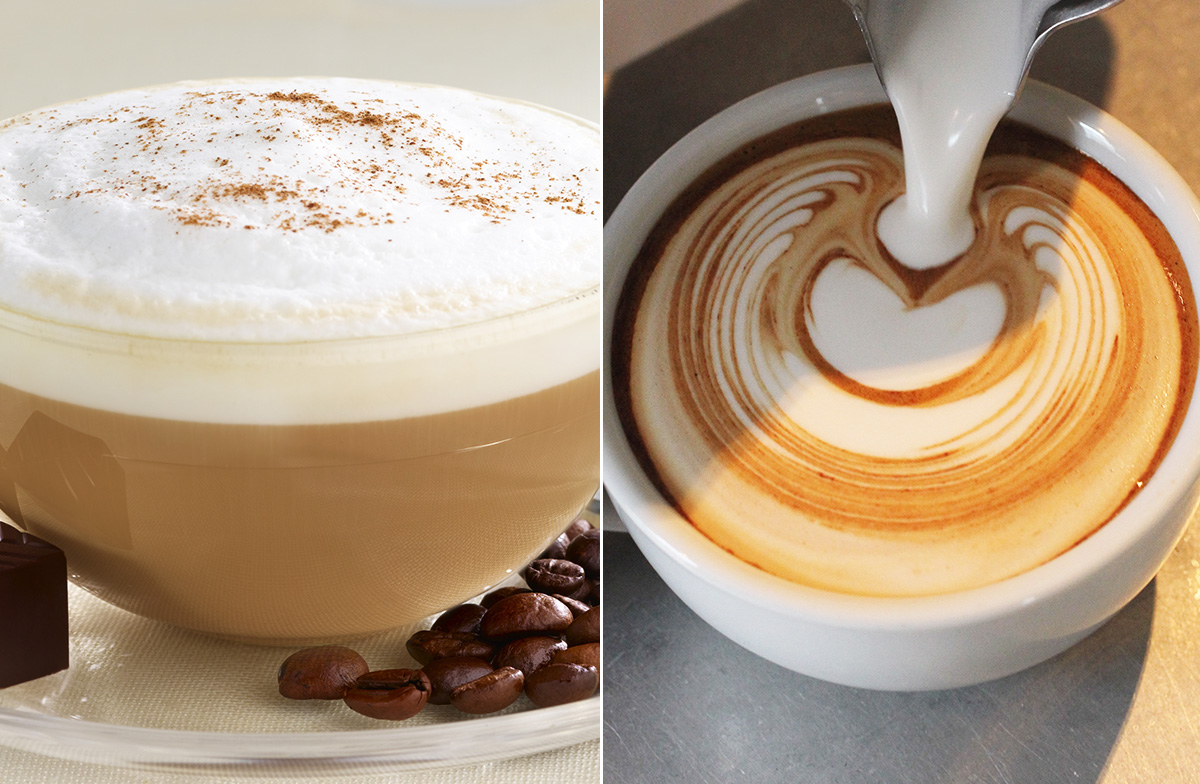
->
[0,0,600,121]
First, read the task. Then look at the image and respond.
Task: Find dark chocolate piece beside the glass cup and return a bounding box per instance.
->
[0,521,70,688]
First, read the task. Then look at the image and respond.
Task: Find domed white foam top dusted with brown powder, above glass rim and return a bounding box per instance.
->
[0,79,600,342]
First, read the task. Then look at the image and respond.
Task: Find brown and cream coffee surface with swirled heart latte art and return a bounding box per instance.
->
[618,114,1196,596]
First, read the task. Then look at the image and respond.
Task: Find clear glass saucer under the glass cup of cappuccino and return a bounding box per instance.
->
[0,511,601,777]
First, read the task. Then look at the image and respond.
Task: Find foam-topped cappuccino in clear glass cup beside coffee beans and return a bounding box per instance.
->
[0,79,600,641]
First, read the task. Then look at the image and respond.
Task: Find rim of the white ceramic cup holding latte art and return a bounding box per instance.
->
[604,64,1200,632]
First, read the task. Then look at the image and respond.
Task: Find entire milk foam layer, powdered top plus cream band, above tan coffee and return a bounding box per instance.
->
[0,79,601,425]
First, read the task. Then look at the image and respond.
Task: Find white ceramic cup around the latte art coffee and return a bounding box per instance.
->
[604,65,1200,690]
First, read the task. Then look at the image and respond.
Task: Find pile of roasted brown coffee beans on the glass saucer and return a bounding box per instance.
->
[278,520,600,720]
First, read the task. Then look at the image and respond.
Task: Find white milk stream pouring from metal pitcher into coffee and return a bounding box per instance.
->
[864,0,1055,269]
